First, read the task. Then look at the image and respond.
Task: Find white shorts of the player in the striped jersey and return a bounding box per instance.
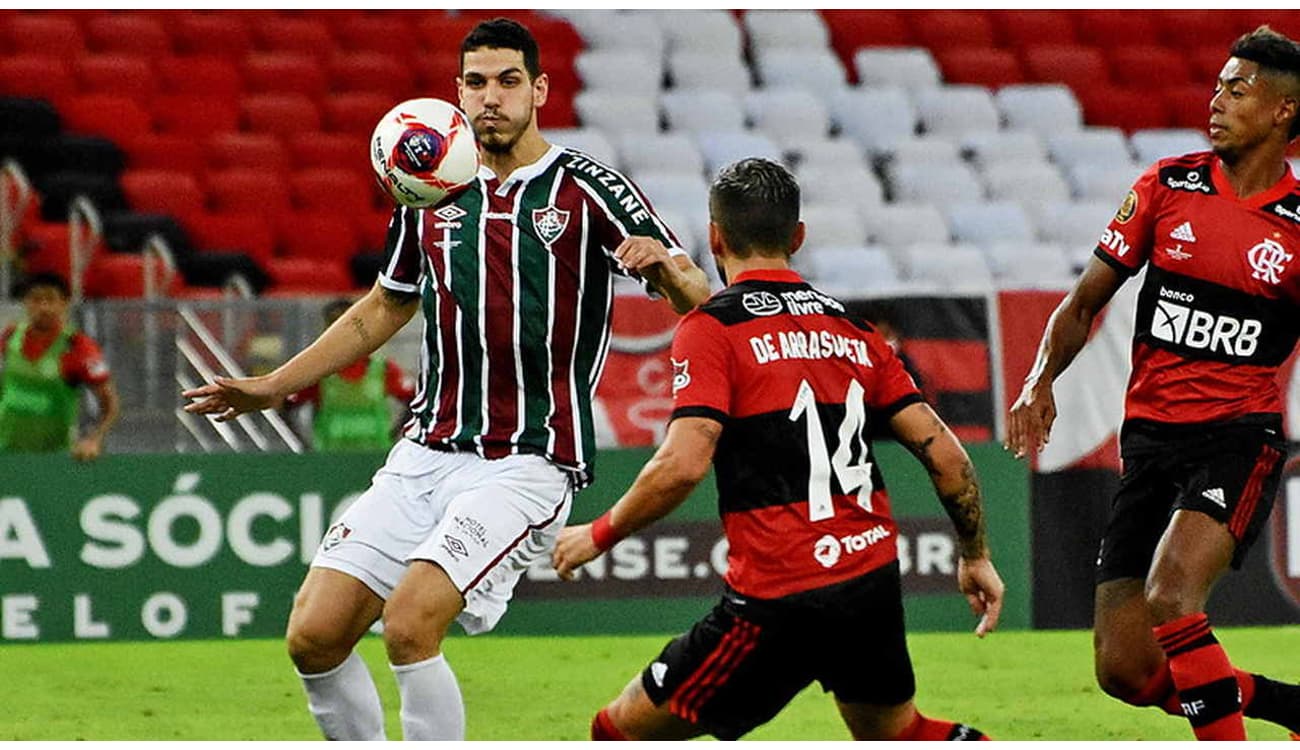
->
[312,439,573,634]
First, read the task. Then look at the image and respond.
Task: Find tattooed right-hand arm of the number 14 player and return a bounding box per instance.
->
[889,403,1004,638]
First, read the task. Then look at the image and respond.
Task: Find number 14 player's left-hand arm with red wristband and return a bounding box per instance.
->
[551,417,723,580]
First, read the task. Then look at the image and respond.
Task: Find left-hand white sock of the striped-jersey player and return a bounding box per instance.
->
[298,651,387,740]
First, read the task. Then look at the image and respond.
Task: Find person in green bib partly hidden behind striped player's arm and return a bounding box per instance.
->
[286,299,415,451]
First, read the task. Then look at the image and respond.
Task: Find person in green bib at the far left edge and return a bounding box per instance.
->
[0,273,118,461]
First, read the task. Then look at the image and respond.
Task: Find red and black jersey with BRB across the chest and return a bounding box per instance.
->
[1095,152,1300,424]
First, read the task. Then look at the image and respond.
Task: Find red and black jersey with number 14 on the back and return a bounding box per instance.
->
[672,270,920,599]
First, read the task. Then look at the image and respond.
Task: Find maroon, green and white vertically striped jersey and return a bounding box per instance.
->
[380,146,684,486]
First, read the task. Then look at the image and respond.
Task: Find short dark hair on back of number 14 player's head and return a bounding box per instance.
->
[709,159,800,257]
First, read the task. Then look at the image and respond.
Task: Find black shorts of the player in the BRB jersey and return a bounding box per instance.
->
[1097,415,1287,584]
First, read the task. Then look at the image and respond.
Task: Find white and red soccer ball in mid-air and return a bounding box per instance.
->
[371,99,478,208]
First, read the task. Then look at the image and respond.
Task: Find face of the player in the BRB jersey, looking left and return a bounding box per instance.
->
[1208,57,1282,161]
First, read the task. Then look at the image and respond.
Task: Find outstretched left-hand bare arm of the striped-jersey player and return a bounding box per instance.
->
[181,283,420,421]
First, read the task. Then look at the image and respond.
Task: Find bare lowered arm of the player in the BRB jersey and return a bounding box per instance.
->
[1006,257,1125,459]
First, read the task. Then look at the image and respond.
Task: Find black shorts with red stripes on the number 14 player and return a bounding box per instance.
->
[641,562,917,740]
